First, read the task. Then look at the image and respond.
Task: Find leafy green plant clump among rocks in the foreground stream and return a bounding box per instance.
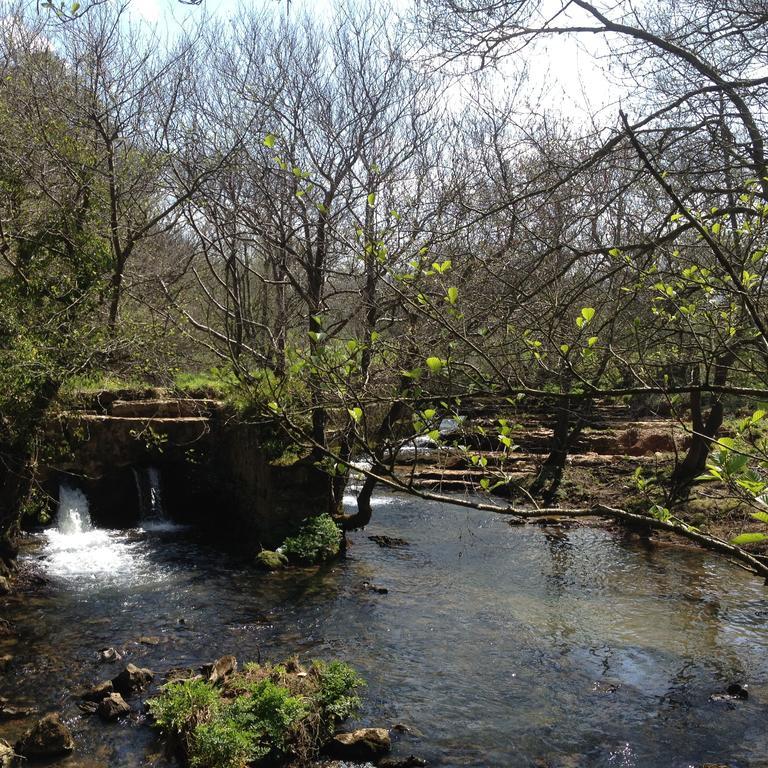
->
[148,659,364,768]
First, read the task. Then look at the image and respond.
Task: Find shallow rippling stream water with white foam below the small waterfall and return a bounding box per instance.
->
[0,491,768,768]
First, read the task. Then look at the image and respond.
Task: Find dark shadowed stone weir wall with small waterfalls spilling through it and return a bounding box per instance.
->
[41,393,330,552]
